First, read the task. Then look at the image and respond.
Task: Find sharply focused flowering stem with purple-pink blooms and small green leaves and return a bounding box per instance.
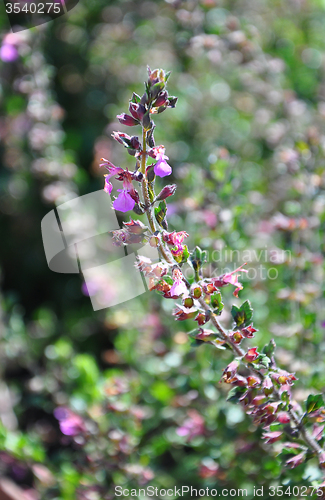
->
[101,68,325,476]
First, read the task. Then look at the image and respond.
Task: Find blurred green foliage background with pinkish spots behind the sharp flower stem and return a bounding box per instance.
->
[0,0,325,500]
